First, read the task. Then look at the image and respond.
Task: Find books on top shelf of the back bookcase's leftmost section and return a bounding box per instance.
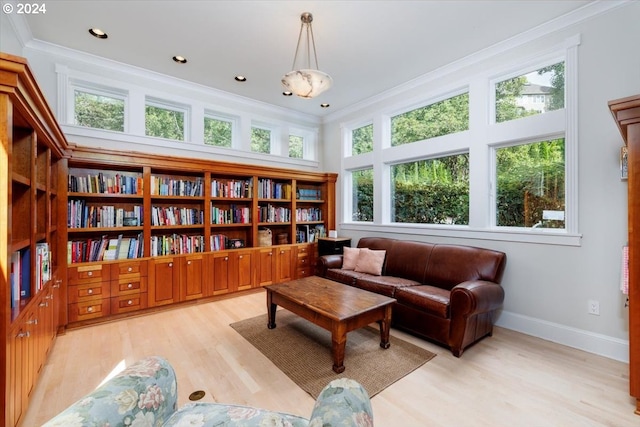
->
[67,172,142,195]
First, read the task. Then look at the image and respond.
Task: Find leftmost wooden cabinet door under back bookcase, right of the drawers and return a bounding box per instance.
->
[148,257,180,307]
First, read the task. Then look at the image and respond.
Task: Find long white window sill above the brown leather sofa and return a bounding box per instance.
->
[340,222,582,246]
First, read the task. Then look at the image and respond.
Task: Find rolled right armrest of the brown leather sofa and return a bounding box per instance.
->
[450,280,504,318]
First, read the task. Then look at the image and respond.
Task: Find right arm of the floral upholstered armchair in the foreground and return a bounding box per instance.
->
[309,378,373,427]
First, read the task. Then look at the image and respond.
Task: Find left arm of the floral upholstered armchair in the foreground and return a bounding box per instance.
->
[43,356,178,427]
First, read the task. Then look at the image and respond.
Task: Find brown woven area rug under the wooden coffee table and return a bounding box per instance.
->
[230,310,435,399]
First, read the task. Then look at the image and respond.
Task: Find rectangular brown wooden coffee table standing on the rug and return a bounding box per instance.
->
[265,276,395,373]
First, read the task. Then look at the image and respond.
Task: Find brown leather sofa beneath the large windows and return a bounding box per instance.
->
[317,237,507,357]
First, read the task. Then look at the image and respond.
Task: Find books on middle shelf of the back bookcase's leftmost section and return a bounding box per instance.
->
[67,200,143,228]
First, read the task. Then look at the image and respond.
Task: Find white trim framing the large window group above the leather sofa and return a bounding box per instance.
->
[340,35,582,246]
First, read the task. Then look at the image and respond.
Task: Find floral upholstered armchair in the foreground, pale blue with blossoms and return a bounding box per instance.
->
[44,356,373,427]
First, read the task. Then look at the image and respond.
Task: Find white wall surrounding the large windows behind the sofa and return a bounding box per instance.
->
[324,2,640,361]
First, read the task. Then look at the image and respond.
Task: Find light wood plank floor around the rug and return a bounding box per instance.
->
[22,291,640,427]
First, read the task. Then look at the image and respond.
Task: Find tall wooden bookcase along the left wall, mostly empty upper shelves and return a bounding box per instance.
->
[0,53,67,426]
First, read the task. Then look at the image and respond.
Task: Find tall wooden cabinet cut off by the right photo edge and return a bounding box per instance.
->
[609,95,640,415]
